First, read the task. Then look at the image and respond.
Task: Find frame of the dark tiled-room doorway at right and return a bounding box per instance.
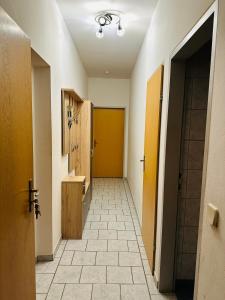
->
[158,1,218,299]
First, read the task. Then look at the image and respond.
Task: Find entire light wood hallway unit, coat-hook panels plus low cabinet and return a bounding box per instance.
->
[62,89,93,239]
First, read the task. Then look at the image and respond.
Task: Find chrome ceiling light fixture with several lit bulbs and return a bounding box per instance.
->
[95,11,125,39]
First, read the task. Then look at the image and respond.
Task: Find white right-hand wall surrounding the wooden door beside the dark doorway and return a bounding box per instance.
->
[128,0,217,292]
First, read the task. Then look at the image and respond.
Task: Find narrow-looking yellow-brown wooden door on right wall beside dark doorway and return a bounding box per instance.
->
[142,66,163,272]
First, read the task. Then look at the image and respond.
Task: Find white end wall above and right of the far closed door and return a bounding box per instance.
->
[88,78,130,177]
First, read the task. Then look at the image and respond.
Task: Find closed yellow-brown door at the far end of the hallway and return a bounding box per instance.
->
[93,108,124,177]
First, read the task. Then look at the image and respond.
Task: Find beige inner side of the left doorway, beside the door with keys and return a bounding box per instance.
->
[32,65,52,258]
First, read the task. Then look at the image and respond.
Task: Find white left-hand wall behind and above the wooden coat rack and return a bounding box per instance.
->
[0,0,87,251]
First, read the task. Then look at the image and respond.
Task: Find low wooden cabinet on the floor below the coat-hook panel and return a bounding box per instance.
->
[62,176,91,239]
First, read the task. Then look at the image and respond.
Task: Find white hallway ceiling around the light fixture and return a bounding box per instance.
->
[57,0,157,78]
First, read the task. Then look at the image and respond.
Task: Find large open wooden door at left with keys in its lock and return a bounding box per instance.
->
[0,8,35,300]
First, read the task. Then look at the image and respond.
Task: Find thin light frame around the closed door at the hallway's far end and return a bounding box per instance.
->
[93,104,129,178]
